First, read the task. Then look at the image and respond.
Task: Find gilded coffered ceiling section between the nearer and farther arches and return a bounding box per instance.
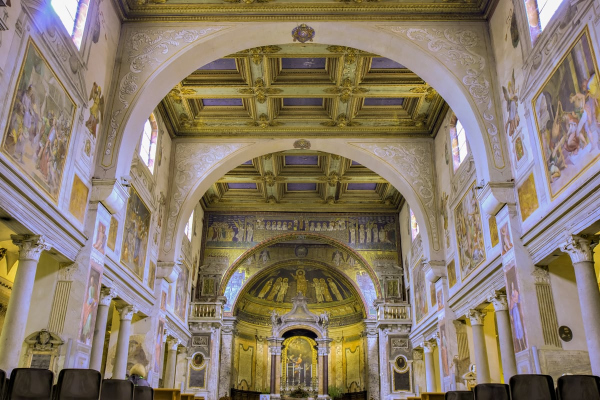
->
[159,44,448,137]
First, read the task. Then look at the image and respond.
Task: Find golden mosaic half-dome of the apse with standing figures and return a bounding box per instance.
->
[234,260,366,326]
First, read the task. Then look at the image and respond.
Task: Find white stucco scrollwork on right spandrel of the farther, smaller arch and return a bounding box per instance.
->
[351,142,440,250]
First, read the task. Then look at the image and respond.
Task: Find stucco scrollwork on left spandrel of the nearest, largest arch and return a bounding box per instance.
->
[102,26,228,167]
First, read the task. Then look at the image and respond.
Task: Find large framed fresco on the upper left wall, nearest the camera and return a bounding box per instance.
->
[2,40,76,203]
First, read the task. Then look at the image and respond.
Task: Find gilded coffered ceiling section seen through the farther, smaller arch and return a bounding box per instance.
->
[201,150,403,212]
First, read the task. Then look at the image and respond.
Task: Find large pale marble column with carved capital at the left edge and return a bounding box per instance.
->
[0,235,50,375]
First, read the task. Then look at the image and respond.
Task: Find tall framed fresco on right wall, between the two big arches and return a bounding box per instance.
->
[454,182,485,281]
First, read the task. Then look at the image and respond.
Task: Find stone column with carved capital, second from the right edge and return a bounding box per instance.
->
[488,292,517,382]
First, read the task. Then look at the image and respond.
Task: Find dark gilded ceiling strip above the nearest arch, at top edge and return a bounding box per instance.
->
[116,0,495,21]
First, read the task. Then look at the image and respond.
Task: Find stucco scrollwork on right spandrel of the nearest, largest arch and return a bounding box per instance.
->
[379,25,504,168]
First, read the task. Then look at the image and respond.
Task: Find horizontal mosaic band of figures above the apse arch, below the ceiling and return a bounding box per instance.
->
[206,213,397,250]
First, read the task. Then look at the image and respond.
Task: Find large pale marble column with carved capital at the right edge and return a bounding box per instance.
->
[560,235,600,375]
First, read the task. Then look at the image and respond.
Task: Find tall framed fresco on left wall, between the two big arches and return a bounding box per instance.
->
[121,186,150,278]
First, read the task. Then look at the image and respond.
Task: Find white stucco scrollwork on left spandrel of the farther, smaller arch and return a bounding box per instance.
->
[163,143,251,253]
